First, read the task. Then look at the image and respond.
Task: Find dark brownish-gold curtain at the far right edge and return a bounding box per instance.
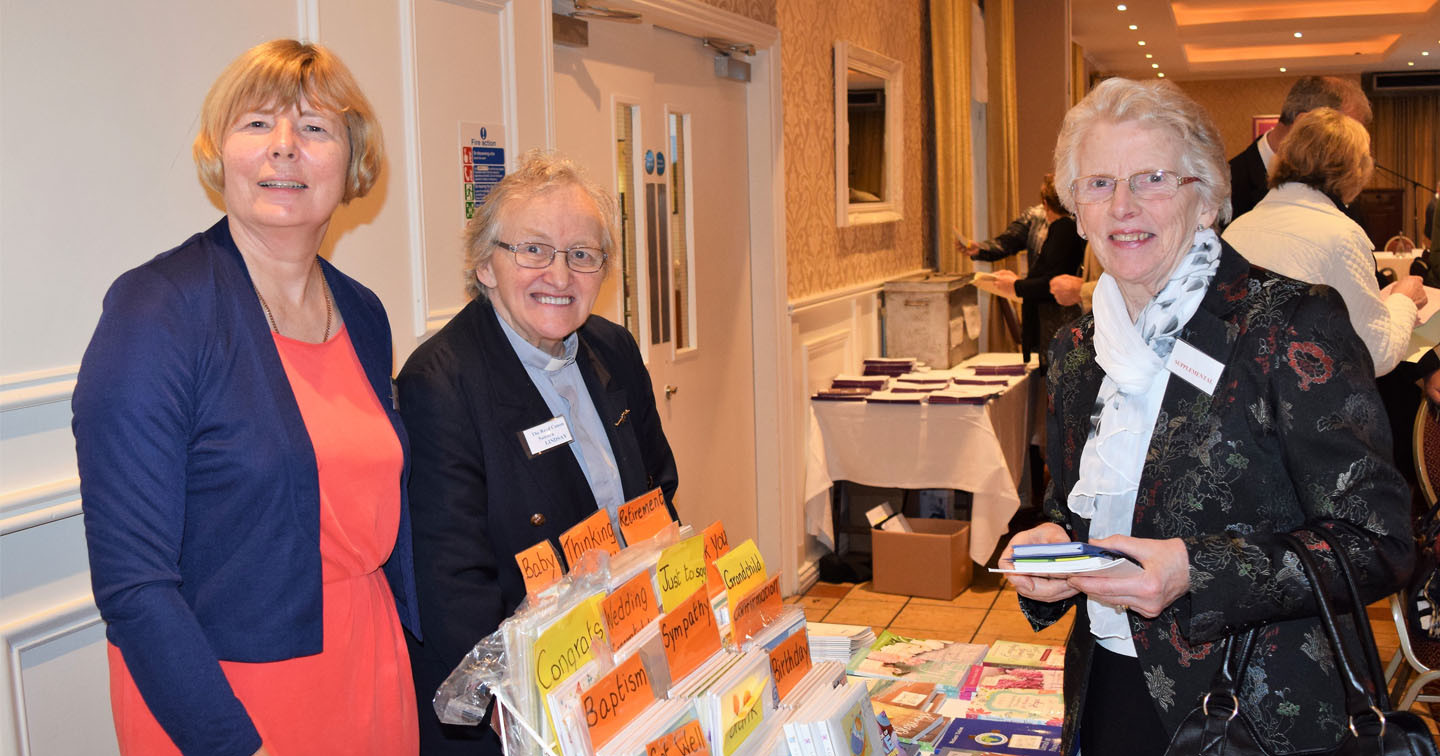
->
[1369,95,1440,243]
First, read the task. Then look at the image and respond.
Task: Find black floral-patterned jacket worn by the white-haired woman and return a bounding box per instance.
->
[1021,245,1414,753]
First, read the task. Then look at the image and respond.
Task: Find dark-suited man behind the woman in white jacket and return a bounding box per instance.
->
[1230,76,1371,223]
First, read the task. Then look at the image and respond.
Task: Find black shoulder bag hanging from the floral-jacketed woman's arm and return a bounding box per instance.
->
[1165,528,1440,756]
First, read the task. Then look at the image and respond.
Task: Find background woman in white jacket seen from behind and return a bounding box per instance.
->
[1224,108,1426,376]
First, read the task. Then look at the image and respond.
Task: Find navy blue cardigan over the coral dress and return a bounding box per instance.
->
[73,219,419,756]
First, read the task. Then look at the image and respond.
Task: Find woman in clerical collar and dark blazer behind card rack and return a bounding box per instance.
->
[397,151,678,756]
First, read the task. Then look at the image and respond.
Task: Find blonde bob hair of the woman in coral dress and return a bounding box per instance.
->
[193,39,384,202]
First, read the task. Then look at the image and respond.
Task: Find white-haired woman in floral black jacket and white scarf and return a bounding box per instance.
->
[1002,79,1413,756]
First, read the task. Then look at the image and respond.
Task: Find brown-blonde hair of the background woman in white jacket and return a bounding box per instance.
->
[1270,108,1375,202]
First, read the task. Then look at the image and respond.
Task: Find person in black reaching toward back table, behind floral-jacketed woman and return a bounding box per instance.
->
[973,173,1084,363]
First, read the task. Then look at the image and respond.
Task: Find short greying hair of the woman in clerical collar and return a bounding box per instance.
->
[464,150,619,300]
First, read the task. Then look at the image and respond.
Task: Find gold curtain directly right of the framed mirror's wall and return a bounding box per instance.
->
[930,0,975,271]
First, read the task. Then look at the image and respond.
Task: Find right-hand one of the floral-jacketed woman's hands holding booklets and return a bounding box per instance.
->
[1071,536,1189,618]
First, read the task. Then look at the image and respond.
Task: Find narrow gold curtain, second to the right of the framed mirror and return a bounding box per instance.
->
[985,0,1022,351]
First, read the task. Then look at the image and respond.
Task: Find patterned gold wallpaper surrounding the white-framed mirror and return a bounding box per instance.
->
[777,0,933,300]
